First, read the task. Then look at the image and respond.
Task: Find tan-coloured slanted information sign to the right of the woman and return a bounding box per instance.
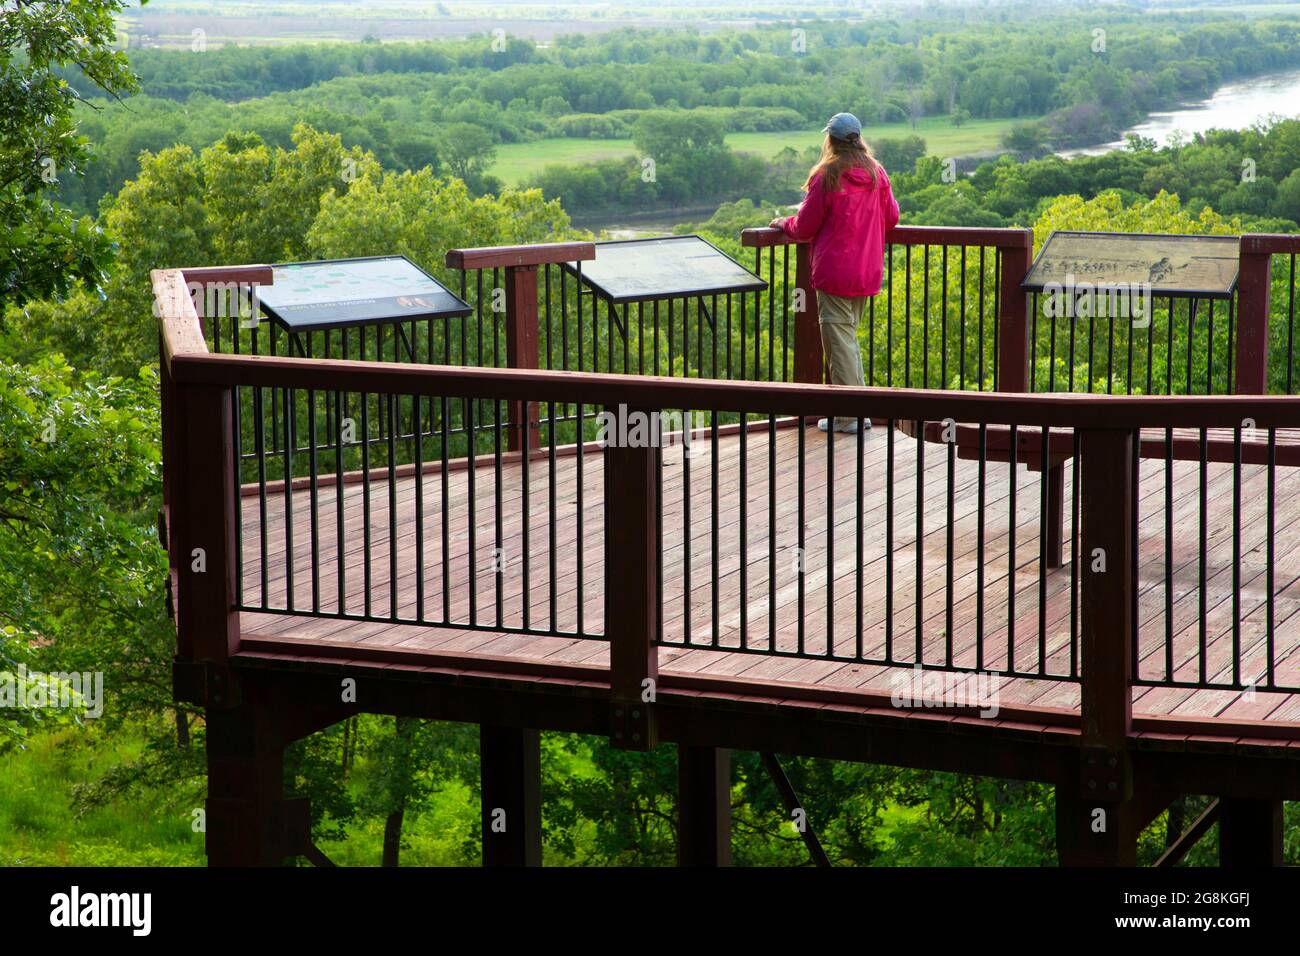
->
[1021,232,1239,299]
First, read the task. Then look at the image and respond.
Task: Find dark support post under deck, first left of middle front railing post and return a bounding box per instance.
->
[478,723,542,866]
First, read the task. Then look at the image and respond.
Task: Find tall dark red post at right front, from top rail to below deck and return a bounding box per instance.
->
[1057,429,1141,866]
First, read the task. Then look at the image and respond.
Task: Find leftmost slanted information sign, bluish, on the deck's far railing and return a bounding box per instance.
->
[257,256,472,332]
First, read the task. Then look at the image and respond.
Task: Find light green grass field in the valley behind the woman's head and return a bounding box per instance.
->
[491,116,1024,186]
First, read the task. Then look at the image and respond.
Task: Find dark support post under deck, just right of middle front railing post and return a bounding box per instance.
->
[677,744,731,866]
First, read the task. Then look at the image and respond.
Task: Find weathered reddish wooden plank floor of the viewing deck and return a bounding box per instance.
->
[241,425,1300,722]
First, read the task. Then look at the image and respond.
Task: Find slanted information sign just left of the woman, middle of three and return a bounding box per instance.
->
[564,235,767,303]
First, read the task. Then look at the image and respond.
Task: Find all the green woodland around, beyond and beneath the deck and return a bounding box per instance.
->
[0,0,1300,865]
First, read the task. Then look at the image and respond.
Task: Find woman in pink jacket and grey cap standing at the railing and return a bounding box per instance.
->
[771,113,898,433]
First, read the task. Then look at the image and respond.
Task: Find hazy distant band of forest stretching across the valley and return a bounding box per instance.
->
[61,8,1300,216]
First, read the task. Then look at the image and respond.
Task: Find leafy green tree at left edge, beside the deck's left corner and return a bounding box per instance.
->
[0,355,167,737]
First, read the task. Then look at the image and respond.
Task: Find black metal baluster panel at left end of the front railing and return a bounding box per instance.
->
[237,388,603,647]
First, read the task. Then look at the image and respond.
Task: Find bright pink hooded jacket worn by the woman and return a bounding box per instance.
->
[781,166,898,297]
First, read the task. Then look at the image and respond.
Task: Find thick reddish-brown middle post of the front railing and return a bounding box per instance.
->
[603,408,660,750]
